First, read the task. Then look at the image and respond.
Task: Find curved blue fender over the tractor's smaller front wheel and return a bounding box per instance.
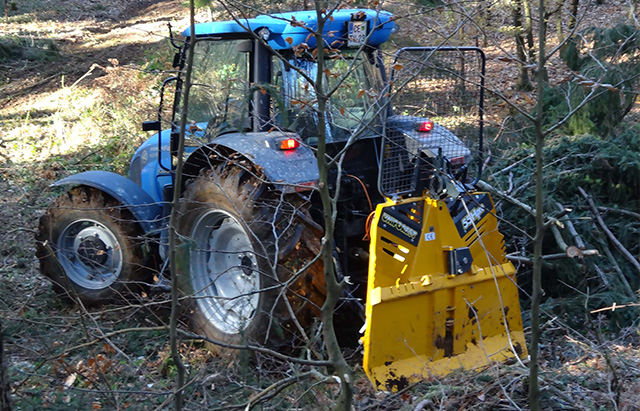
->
[51,171,162,234]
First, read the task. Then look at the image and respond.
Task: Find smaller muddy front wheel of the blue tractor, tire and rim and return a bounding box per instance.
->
[36,186,152,305]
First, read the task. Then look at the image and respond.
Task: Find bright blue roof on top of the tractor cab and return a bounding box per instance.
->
[182,9,395,50]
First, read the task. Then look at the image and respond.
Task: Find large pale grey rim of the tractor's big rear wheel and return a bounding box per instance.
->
[190,210,260,334]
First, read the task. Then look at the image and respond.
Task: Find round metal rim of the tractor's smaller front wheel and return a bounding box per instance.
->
[56,220,124,290]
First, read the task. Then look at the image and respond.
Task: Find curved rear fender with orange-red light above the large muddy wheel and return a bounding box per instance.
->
[183,132,319,193]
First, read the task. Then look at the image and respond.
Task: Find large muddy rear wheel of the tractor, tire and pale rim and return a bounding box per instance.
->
[177,164,325,353]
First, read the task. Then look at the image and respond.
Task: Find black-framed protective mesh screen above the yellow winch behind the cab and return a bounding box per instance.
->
[380,47,484,197]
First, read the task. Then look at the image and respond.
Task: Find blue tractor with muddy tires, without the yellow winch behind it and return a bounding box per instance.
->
[37,9,492,358]
